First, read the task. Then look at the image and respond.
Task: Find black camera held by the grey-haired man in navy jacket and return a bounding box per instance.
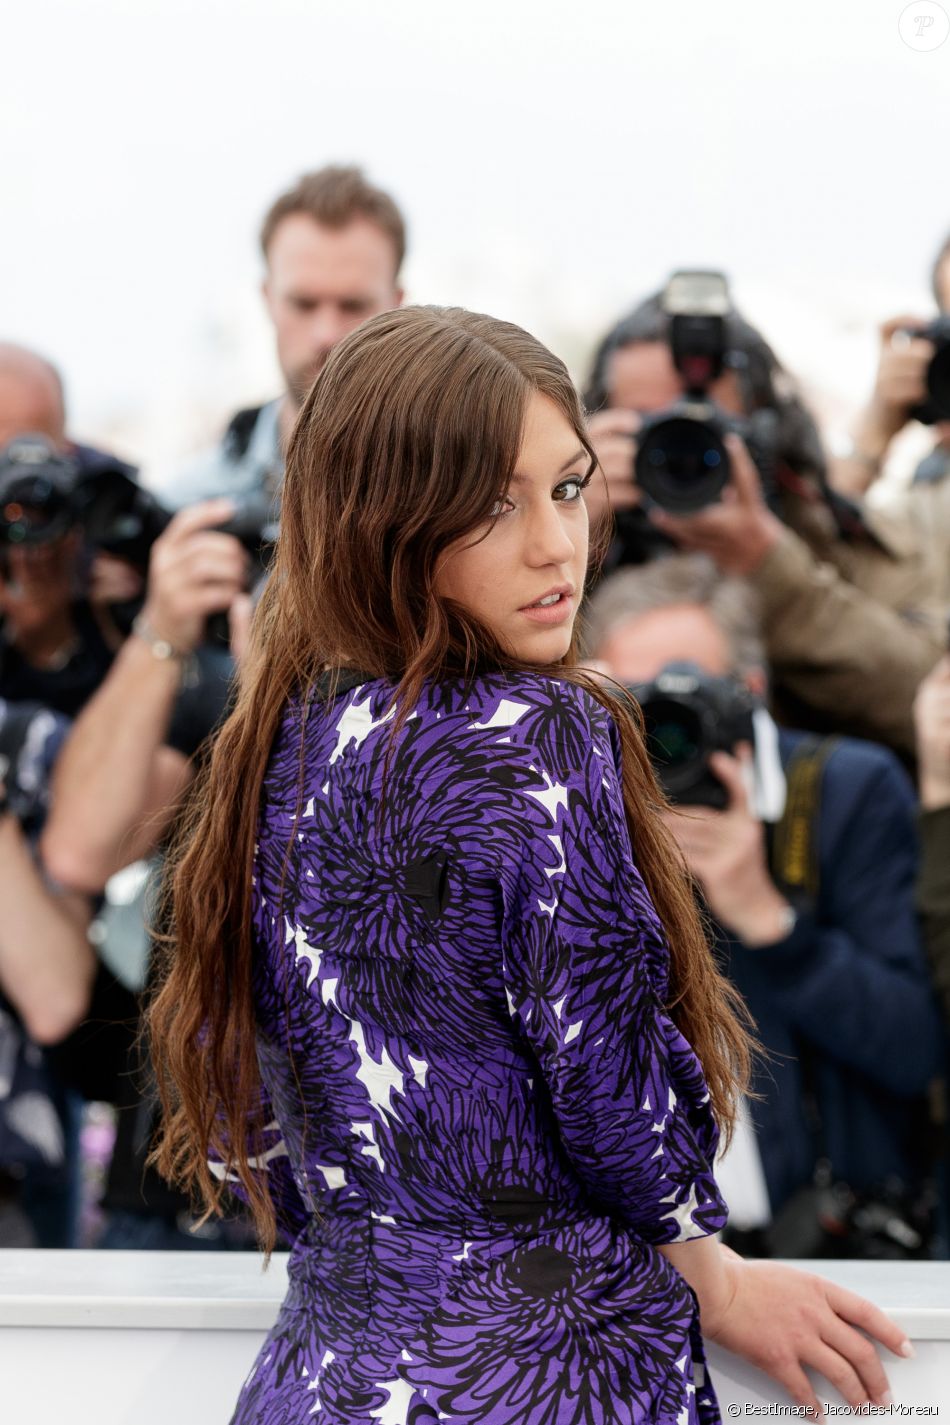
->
[628,663,756,811]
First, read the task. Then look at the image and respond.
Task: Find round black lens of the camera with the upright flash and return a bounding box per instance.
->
[637,416,729,514]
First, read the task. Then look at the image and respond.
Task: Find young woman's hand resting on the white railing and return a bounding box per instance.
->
[702,1248,913,1419]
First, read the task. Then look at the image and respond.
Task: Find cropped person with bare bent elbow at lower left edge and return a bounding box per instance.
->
[0,700,95,1247]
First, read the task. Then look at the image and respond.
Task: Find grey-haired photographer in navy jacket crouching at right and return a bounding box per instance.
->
[588,556,941,1255]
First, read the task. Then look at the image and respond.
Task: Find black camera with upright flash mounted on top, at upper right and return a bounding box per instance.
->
[634,272,776,514]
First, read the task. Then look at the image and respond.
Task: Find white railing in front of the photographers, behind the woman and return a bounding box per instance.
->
[0,1251,950,1425]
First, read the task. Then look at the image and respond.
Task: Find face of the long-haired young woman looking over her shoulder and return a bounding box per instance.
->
[436,393,590,663]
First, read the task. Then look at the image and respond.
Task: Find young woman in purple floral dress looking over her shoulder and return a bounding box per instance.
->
[151,308,904,1425]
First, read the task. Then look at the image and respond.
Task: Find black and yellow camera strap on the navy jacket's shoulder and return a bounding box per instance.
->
[766,737,839,911]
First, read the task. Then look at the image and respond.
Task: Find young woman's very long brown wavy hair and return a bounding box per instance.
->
[148,306,749,1250]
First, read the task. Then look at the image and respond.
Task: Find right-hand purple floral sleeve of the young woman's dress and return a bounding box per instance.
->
[501,690,726,1244]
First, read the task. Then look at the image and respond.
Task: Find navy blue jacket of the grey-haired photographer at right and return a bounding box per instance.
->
[722,731,943,1213]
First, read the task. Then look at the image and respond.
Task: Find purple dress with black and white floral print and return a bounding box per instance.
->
[232,674,726,1425]
